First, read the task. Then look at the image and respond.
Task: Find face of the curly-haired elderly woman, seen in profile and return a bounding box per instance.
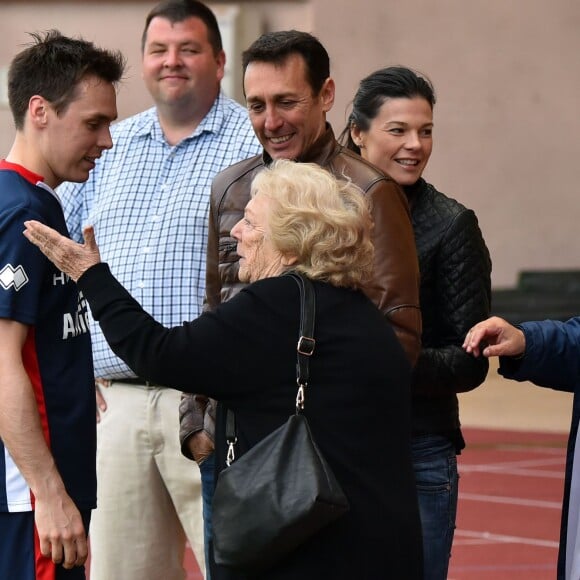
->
[231,195,287,283]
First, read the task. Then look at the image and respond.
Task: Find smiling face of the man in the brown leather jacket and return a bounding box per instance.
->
[244,54,334,159]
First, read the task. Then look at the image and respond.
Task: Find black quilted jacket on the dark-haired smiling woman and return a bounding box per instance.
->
[405,179,491,451]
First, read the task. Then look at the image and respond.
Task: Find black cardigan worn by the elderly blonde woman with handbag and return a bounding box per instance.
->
[79,264,423,580]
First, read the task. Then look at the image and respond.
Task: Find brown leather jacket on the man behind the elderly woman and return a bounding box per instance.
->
[180,125,421,457]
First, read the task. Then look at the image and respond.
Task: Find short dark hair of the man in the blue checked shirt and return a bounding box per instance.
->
[141,0,223,54]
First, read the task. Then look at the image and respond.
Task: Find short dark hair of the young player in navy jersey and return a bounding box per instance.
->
[8,30,125,130]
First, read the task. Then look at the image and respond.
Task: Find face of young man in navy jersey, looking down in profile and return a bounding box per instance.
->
[38,77,117,188]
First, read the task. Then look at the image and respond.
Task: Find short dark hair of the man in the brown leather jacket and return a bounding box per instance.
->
[242,30,330,95]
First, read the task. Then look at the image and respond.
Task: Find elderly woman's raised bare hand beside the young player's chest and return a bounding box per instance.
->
[24,220,101,282]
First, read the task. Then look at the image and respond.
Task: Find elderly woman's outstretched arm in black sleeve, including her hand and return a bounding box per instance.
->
[25,222,290,402]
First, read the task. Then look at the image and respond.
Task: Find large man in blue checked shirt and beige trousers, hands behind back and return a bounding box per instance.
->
[58,0,260,580]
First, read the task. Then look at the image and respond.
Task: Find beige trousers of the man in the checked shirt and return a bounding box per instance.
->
[90,382,205,580]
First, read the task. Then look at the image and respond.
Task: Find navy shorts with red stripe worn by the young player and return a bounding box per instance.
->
[0,512,91,580]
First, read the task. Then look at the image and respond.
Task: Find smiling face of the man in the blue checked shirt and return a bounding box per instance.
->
[142,16,225,112]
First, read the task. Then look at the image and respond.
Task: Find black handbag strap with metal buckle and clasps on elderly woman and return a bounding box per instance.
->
[226,270,316,467]
